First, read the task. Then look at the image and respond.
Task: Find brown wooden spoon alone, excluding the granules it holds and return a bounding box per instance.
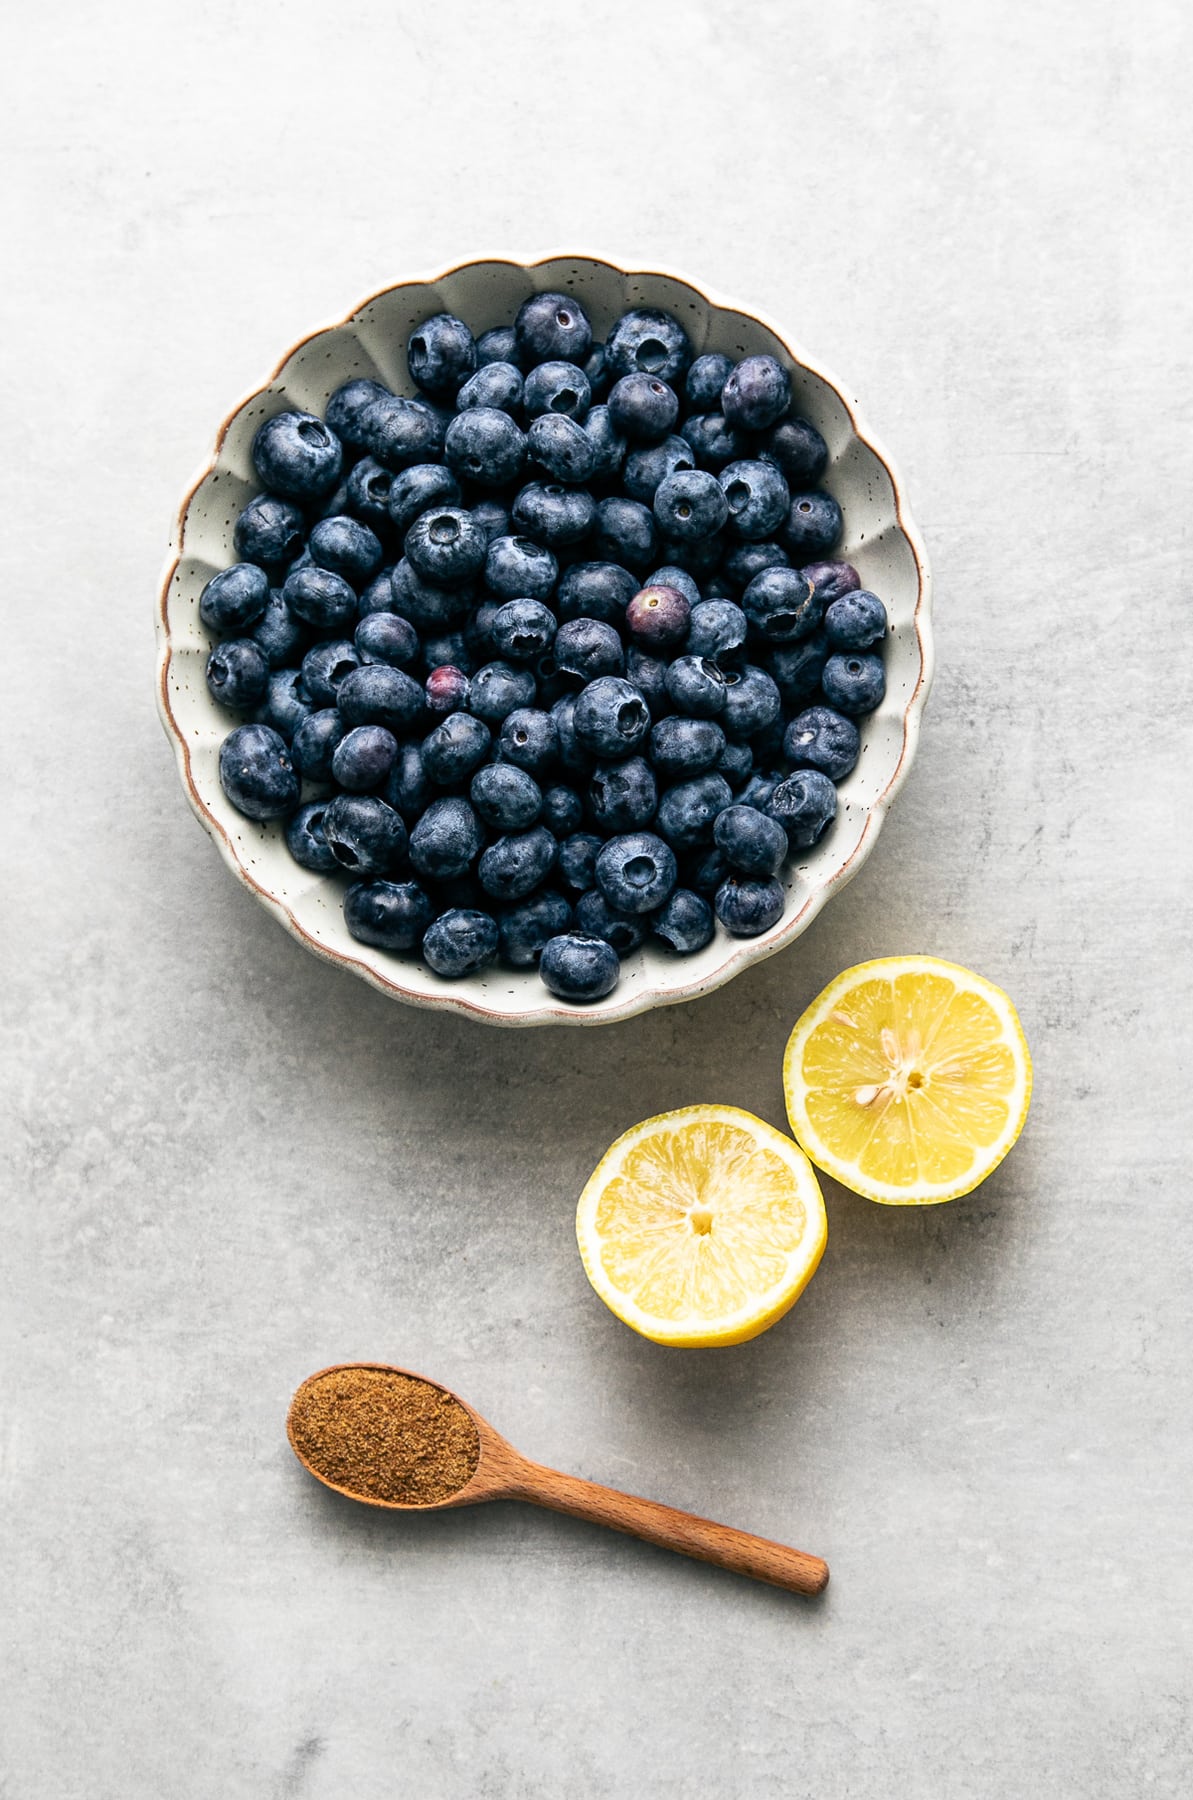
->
[286,1363,828,1593]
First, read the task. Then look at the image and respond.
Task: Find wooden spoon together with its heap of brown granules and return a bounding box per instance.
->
[286,1363,828,1593]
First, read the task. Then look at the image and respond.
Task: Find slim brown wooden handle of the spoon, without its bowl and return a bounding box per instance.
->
[516,1462,828,1593]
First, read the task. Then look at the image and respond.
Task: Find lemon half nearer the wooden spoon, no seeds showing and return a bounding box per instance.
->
[576,1107,828,1346]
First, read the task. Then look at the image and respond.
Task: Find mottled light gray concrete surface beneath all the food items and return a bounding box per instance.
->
[0,0,1193,1800]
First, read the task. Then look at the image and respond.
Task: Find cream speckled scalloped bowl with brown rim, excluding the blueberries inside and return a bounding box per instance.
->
[157,254,932,1026]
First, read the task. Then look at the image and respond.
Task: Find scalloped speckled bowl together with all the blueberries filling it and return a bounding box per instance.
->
[158,256,932,1026]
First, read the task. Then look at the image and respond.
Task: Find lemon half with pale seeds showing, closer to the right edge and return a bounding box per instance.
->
[783,956,1031,1206]
